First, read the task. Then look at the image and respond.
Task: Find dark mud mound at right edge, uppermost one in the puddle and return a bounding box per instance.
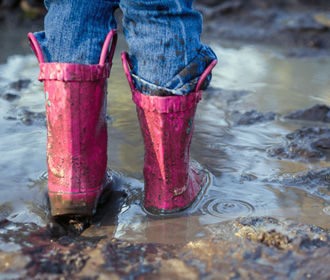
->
[285,104,330,123]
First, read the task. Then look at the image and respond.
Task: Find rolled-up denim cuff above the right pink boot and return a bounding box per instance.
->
[131,45,217,96]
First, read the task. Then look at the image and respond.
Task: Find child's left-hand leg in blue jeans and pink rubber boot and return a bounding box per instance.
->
[29,0,116,216]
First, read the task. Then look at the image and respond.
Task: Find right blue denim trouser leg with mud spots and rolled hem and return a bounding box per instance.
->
[120,0,215,95]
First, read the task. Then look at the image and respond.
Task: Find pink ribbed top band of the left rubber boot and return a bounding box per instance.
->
[39,63,111,82]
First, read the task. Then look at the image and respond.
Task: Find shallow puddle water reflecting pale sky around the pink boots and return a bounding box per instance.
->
[0,40,330,250]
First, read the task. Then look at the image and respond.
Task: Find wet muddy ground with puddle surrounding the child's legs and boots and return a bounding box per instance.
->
[0,0,330,279]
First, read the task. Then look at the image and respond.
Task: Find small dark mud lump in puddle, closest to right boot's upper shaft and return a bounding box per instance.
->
[231,110,277,125]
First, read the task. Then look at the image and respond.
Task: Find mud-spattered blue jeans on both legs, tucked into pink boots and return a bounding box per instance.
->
[35,0,216,95]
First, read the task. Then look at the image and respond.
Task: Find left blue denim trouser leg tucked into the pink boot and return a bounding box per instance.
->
[35,0,118,64]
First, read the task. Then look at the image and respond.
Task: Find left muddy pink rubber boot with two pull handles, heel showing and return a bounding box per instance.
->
[28,30,117,216]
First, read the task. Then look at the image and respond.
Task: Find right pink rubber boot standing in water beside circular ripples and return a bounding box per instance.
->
[122,53,217,214]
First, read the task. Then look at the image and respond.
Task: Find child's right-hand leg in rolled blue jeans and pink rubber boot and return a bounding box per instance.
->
[120,0,216,213]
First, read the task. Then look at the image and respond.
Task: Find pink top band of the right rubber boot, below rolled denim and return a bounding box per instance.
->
[133,88,202,113]
